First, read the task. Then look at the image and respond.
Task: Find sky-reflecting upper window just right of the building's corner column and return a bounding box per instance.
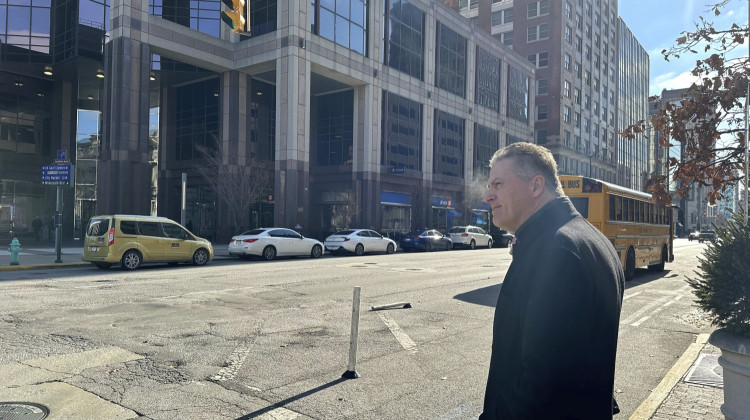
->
[311,0,367,55]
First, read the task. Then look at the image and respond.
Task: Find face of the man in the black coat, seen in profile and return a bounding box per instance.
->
[484,159,534,232]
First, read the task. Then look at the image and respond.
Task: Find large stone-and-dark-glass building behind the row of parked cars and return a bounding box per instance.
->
[0,0,538,240]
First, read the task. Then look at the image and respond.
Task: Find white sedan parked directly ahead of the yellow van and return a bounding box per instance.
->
[227,228,323,261]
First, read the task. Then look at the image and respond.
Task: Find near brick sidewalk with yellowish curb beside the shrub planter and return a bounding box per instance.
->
[632,334,724,420]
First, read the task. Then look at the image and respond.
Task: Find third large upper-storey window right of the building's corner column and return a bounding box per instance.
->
[435,23,466,98]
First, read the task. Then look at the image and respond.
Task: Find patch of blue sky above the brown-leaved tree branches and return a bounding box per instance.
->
[619,0,748,95]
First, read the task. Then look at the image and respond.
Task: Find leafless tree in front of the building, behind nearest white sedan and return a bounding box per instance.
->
[197,146,269,232]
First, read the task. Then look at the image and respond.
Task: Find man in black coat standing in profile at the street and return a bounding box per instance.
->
[479,143,625,420]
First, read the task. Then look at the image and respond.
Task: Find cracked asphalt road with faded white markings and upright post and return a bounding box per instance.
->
[0,240,708,420]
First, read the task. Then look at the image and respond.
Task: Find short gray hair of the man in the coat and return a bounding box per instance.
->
[490,142,565,197]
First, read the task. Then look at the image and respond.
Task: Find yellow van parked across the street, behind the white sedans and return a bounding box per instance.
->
[81,215,214,270]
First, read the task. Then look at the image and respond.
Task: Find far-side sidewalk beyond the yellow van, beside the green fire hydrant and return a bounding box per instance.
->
[0,242,230,272]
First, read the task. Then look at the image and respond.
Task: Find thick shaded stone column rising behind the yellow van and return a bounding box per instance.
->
[97,37,152,214]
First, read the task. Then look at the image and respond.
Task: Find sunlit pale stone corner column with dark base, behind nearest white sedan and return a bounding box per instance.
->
[274,55,310,229]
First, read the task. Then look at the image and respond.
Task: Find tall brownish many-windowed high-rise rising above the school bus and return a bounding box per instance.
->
[458,0,649,189]
